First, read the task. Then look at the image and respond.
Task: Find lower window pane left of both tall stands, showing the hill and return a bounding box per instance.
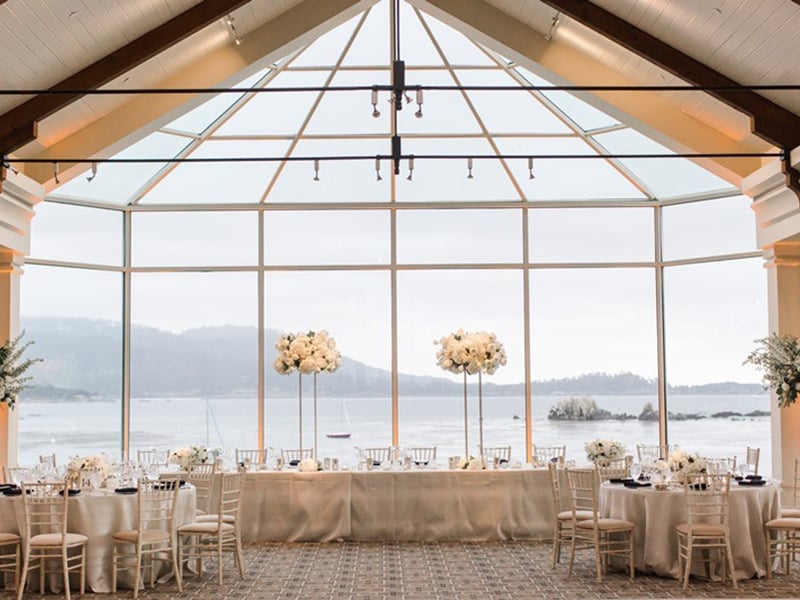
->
[130,273,258,455]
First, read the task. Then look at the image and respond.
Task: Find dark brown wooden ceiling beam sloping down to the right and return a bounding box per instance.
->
[541,0,800,149]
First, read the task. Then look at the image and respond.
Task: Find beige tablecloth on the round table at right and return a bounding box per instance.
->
[600,482,780,578]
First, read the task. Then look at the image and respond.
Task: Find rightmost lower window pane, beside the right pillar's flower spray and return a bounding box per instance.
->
[664,258,771,473]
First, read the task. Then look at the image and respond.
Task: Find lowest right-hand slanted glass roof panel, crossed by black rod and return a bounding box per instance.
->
[594,129,731,198]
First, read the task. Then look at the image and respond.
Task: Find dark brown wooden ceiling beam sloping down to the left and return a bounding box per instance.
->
[0,0,250,155]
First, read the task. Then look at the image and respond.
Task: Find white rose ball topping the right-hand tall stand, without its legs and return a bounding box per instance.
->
[434,329,506,375]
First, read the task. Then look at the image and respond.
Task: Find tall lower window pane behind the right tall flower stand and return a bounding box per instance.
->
[397,269,525,462]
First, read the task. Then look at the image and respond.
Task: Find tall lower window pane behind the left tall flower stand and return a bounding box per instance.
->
[264,271,392,465]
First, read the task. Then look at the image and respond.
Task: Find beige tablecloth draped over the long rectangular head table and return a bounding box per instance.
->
[242,469,553,542]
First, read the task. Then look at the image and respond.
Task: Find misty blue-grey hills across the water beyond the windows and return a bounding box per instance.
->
[22,317,761,399]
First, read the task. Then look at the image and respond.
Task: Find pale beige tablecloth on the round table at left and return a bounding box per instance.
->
[0,487,195,593]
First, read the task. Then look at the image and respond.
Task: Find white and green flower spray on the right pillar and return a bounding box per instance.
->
[744,333,800,408]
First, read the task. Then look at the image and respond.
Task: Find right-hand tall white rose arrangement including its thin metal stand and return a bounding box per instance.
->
[434,329,506,462]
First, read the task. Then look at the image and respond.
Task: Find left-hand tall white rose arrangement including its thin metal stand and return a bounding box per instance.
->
[273,329,342,458]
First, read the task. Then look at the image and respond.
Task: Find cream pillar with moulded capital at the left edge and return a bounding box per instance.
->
[0,170,44,467]
